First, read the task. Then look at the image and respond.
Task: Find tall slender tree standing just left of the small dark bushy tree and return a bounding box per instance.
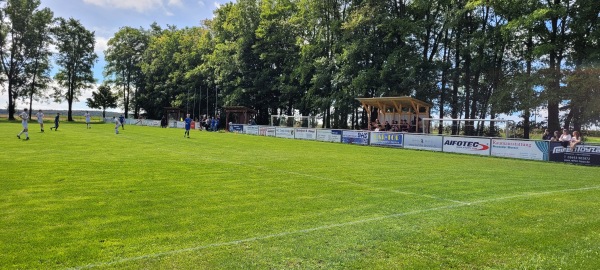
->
[53,18,98,121]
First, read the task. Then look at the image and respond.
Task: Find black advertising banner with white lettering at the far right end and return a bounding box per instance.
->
[550,142,600,166]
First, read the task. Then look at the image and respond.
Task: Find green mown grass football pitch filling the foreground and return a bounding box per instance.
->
[0,120,600,269]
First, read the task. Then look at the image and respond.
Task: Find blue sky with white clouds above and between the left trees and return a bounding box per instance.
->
[0,0,235,110]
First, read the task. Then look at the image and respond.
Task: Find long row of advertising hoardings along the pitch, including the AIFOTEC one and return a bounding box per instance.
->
[232,125,600,165]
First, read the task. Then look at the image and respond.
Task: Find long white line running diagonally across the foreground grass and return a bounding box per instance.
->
[69,186,600,269]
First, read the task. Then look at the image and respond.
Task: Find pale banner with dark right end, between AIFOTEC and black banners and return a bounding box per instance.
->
[491,139,548,160]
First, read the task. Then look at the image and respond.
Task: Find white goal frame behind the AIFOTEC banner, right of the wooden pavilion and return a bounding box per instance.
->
[422,118,515,138]
